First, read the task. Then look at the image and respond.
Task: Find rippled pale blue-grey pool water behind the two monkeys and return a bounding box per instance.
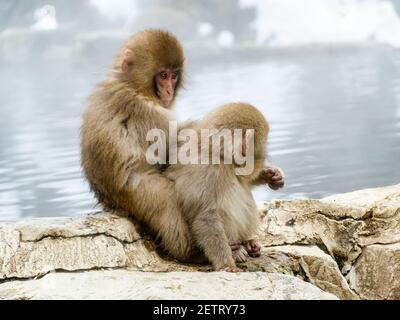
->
[0,46,400,220]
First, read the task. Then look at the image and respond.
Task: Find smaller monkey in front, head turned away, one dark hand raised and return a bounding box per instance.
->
[165,103,284,272]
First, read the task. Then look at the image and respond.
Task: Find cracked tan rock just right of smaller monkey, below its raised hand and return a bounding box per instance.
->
[260,200,363,272]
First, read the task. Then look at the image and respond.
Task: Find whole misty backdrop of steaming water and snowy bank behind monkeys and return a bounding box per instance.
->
[0,0,400,220]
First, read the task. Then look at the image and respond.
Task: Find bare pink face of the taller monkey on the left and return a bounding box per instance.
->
[155,69,179,108]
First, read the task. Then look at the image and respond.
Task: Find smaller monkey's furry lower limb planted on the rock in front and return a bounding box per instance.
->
[192,210,242,272]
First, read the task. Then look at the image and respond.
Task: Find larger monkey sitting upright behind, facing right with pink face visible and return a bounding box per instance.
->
[81,30,192,261]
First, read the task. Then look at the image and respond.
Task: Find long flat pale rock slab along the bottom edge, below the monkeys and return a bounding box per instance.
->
[0,270,337,300]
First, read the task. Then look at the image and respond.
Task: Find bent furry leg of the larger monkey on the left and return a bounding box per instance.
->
[126,173,193,261]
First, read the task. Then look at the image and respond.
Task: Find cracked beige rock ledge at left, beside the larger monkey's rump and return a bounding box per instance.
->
[0,213,179,279]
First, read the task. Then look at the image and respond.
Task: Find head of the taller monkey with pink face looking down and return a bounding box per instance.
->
[114,30,185,108]
